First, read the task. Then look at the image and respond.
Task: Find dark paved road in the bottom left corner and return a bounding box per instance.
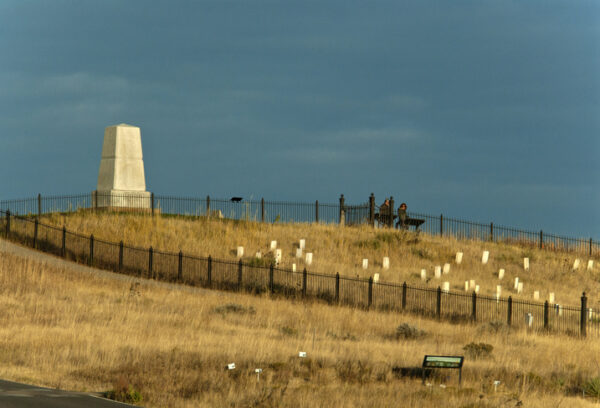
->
[0,380,135,408]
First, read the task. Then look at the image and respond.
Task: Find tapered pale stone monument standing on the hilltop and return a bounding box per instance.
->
[93,123,151,208]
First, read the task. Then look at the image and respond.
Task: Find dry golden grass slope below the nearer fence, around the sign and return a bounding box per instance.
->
[0,242,600,408]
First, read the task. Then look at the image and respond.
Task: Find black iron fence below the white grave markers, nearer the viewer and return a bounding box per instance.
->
[0,211,600,336]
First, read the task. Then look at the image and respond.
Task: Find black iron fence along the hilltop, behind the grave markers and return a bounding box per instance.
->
[0,192,600,257]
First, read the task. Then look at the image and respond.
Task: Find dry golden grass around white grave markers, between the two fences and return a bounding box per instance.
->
[44,212,600,309]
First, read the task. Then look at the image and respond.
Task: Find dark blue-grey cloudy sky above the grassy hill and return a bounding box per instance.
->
[0,0,600,239]
